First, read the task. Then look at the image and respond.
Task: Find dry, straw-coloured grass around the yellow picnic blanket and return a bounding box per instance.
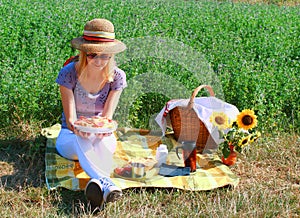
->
[0,134,300,217]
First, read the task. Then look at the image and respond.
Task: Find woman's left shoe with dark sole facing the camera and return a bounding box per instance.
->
[85,179,104,211]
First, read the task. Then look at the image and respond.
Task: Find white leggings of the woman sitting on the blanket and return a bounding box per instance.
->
[56,129,117,179]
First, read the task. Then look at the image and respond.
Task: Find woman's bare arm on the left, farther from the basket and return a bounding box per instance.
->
[59,85,76,131]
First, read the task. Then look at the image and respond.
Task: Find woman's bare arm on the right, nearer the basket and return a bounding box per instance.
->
[102,90,123,119]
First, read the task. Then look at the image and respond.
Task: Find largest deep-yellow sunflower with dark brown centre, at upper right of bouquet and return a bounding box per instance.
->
[236,109,257,130]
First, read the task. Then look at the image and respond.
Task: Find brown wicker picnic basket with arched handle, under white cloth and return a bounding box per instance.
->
[169,85,215,153]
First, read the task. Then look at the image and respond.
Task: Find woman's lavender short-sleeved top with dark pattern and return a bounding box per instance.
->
[56,62,127,128]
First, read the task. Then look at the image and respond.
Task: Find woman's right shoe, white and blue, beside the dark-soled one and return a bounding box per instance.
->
[100,177,122,202]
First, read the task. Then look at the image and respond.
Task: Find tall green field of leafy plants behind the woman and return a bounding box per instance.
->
[0,1,300,135]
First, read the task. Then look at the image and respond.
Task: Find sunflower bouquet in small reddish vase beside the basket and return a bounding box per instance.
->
[210,109,261,165]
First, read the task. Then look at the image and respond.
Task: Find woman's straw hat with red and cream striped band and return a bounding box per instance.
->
[71,19,126,54]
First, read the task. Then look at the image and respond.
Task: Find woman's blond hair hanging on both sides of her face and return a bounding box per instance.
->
[76,51,116,85]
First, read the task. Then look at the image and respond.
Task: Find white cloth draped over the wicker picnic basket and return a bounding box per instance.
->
[155,97,239,144]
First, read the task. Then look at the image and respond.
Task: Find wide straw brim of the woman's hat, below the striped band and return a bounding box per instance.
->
[71,37,126,54]
